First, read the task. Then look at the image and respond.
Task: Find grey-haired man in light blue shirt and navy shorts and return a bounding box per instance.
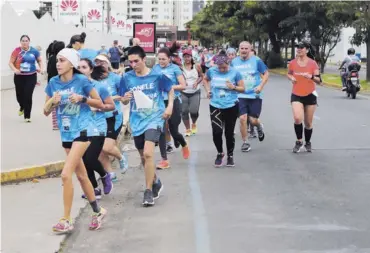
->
[231,41,269,152]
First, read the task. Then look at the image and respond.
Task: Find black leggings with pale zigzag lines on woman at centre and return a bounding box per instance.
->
[210,105,239,156]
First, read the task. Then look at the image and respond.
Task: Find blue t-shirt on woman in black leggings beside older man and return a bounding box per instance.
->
[206,67,243,109]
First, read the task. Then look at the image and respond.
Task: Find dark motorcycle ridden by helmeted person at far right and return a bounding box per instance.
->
[341,62,361,99]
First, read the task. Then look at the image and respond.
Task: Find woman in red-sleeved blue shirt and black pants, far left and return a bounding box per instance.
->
[9,35,43,123]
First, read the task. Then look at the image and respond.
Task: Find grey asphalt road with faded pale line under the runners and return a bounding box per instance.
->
[63,76,370,253]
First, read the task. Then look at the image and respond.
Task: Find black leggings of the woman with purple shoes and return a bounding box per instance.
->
[82,136,107,188]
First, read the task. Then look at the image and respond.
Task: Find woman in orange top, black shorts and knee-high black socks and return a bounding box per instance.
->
[287,41,321,153]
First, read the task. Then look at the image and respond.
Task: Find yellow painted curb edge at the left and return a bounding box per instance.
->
[1,161,64,184]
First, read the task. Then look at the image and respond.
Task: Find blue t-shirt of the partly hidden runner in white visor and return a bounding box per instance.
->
[99,72,123,130]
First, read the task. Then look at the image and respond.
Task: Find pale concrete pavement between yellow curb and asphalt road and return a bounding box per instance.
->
[0,148,140,253]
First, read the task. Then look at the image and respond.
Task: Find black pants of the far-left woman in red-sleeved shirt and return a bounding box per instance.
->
[14,73,37,119]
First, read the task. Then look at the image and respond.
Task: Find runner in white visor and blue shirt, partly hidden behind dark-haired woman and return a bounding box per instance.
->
[92,54,127,181]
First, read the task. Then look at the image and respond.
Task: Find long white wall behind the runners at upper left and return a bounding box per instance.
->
[0,4,129,89]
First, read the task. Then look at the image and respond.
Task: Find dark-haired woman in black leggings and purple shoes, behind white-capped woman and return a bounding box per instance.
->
[78,58,115,199]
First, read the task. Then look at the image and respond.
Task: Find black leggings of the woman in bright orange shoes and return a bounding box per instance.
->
[159,98,186,160]
